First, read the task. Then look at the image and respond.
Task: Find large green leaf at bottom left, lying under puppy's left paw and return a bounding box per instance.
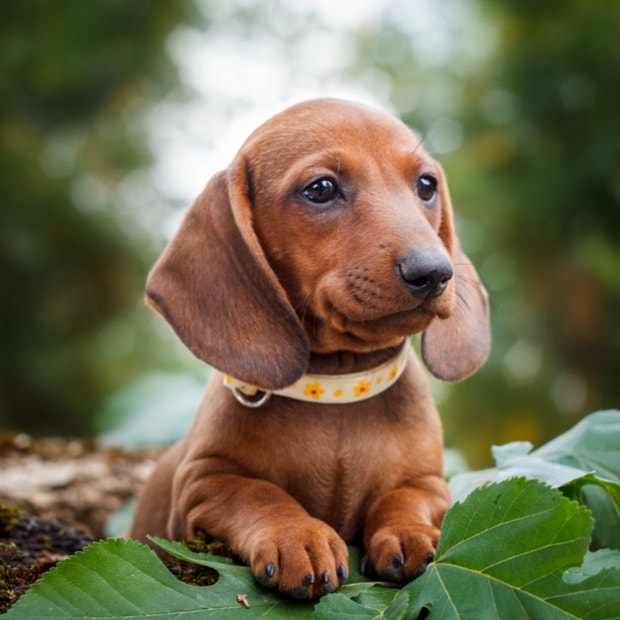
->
[6,539,313,620]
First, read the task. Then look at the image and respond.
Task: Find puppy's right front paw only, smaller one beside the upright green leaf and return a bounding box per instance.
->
[362,524,439,583]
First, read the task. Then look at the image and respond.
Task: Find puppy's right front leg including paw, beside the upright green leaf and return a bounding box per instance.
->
[362,476,450,583]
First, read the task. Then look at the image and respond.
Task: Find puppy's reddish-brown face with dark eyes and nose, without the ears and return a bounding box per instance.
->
[240,103,454,353]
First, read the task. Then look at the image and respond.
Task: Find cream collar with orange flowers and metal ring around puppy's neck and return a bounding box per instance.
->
[224,339,410,408]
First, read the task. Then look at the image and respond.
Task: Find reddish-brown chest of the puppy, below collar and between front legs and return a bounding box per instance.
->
[247,410,416,542]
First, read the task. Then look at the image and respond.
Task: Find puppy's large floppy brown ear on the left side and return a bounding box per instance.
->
[146,161,309,390]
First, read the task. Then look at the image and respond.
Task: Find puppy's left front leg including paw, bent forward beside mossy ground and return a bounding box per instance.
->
[170,470,348,598]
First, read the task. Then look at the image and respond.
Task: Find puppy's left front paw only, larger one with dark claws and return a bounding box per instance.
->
[250,517,349,599]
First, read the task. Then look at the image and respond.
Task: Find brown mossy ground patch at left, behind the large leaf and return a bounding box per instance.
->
[0,434,161,614]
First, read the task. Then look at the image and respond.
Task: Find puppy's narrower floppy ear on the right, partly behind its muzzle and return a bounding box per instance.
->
[422,172,491,381]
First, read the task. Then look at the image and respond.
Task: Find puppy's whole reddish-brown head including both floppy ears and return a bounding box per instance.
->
[147,99,490,389]
